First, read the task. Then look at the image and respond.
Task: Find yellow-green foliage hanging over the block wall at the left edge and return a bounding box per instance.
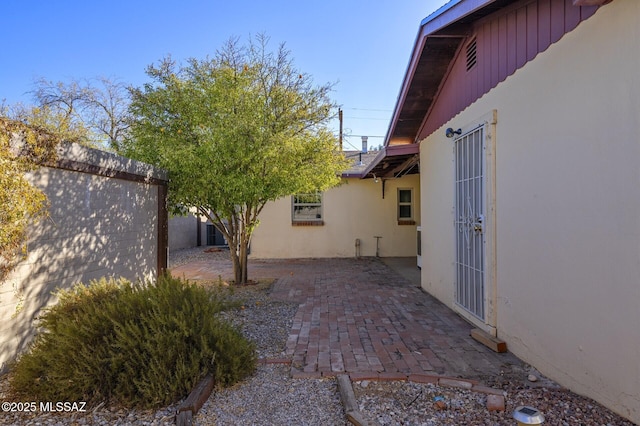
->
[0,117,59,282]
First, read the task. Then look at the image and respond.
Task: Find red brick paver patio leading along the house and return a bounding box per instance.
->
[172,258,525,381]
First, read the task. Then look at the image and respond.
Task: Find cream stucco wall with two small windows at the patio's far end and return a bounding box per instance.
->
[251,175,420,258]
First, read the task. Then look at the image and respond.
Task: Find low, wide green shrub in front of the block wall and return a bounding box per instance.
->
[10,276,256,408]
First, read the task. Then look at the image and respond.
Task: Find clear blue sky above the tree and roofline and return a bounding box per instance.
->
[0,0,446,149]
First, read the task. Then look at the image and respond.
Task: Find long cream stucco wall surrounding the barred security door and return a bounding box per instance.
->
[421,0,640,423]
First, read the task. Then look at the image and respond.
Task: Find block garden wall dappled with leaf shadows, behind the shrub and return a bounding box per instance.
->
[0,145,164,370]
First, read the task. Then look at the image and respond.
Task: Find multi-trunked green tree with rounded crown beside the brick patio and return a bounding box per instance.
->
[125,35,347,284]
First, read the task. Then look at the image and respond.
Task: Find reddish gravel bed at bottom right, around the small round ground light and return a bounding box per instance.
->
[353,381,633,426]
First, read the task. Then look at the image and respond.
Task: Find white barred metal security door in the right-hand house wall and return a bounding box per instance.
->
[454,126,485,321]
